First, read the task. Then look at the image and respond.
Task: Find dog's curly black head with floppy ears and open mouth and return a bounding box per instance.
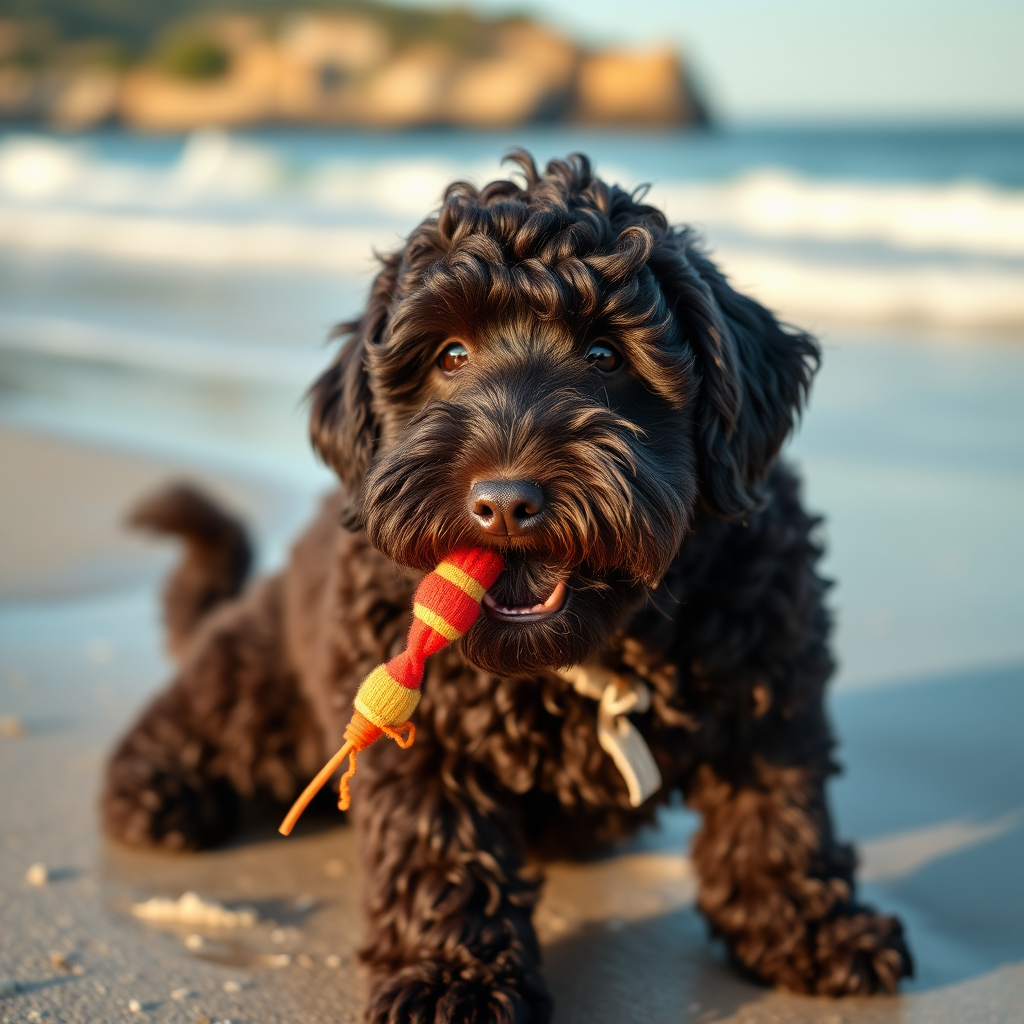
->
[311,153,817,673]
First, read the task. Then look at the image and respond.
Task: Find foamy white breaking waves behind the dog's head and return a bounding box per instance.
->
[0,131,1024,329]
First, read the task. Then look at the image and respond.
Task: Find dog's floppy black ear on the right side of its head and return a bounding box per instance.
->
[651,232,820,519]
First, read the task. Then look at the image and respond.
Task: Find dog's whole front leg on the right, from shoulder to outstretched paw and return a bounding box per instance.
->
[685,474,912,995]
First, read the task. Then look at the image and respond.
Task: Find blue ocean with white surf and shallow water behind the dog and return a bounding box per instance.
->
[0,127,1024,681]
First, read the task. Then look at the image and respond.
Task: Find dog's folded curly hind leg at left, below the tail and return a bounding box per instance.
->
[102,578,322,850]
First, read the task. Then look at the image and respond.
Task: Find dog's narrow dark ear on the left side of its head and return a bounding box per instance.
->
[308,257,398,529]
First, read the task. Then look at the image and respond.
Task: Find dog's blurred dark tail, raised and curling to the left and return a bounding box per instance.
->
[127,483,253,658]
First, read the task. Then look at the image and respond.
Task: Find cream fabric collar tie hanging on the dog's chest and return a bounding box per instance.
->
[558,663,662,807]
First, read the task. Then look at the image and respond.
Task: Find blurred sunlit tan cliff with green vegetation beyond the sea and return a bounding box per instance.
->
[0,0,705,131]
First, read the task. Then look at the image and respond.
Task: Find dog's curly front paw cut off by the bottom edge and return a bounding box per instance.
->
[367,961,551,1024]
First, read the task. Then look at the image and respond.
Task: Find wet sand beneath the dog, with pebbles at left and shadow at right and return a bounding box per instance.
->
[0,429,1024,1024]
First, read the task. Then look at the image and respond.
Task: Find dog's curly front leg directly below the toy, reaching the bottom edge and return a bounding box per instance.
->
[353,728,551,1024]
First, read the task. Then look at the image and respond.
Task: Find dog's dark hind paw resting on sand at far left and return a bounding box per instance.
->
[102,752,238,850]
